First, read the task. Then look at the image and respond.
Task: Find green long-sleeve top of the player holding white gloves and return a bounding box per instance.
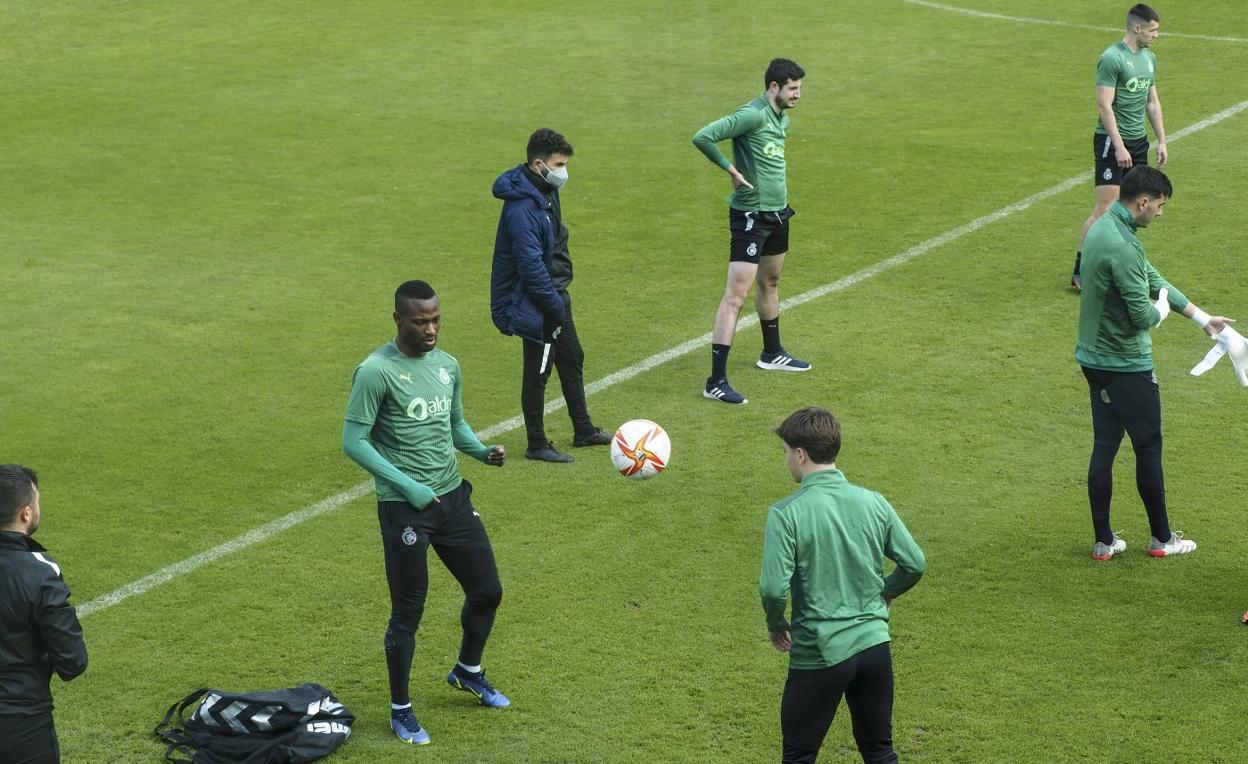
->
[1075,201,1189,372]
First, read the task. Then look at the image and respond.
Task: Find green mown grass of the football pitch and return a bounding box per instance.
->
[0,0,1248,764]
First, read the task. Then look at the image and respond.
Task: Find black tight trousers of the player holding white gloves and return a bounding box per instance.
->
[1082,366,1171,544]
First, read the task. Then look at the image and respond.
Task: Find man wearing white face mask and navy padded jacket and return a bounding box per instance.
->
[489,127,612,462]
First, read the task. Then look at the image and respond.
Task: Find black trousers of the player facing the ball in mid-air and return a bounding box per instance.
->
[377,481,503,704]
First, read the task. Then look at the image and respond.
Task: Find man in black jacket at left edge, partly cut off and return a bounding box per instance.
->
[0,464,86,764]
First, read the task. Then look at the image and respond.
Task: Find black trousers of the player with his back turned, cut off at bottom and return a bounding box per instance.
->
[780,642,897,764]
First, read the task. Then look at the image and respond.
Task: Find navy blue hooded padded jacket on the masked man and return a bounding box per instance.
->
[489,165,563,342]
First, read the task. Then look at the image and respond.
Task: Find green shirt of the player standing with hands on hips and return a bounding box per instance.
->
[694,94,789,212]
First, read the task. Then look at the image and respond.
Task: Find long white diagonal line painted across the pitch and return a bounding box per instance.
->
[77,95,1248,618]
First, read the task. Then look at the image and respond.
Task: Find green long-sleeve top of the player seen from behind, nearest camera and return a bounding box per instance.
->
[759,469,926,669]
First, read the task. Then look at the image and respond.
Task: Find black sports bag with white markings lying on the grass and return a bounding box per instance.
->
[152,683,356,764]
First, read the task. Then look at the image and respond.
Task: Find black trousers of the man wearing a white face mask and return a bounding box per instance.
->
[520,292,594,448]
